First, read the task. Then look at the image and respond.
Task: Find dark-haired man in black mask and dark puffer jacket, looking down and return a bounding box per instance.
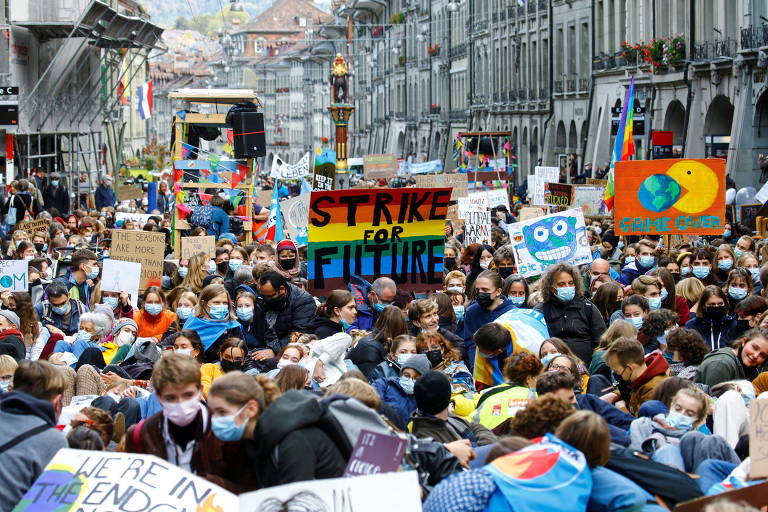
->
[252,270,317,362]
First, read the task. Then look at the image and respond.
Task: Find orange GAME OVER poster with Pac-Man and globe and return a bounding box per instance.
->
[614,158,726,235]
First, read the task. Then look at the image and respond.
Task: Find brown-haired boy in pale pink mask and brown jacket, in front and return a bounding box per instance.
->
[125,353,254,490]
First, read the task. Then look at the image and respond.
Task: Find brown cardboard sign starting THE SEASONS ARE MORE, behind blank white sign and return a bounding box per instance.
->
[109,229,165,290]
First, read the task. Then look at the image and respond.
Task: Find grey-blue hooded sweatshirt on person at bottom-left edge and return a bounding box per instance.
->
[0,391,67,510]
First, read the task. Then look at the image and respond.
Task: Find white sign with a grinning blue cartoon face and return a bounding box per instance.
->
[509,208,592,277]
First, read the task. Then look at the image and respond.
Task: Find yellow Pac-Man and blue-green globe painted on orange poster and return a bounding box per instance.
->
[637,160,719,214]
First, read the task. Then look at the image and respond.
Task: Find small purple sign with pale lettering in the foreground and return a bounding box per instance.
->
[344,430,405,476]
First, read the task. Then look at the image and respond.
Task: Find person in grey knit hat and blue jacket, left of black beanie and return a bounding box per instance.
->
[371,354,432,430]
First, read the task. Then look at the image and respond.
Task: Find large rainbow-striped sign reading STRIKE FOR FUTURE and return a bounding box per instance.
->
[308,188,451,295]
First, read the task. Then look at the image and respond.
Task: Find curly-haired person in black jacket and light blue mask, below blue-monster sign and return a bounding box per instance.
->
[536,263,605,366]
